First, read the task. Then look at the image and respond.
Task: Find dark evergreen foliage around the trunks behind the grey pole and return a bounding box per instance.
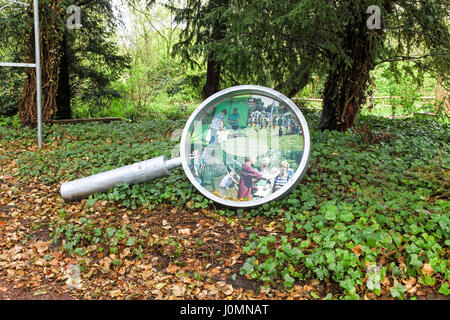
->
[0,0,129,121]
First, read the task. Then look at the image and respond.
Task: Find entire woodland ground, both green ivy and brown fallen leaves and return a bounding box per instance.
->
[0,111,450,299]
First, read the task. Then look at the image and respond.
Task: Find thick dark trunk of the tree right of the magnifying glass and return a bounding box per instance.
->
[319,1,392,131]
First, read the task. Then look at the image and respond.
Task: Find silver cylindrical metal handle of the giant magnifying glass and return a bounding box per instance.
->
[61,156,181,201]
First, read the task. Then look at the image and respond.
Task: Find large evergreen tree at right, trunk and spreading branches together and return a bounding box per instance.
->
[171,0,450,131]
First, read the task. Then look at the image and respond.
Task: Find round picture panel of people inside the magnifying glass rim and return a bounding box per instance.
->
[188,95,304,201]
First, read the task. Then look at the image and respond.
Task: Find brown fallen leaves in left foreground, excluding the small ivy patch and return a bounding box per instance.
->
[0,148,449,300]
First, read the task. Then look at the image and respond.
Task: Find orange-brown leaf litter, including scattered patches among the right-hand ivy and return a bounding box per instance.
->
[0,118,448,299]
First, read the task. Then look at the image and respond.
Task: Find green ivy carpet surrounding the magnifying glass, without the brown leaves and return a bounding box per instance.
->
[0,111,450,299]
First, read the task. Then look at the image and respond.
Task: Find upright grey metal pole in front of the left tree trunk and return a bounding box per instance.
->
[33,0,42,149]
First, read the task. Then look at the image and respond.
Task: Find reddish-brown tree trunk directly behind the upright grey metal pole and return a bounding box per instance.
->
[19,0,62,127]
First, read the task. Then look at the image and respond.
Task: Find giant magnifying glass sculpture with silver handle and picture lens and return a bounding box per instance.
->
[61,85,310,208]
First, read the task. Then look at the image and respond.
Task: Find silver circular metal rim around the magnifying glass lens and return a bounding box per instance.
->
[180,85,311,208]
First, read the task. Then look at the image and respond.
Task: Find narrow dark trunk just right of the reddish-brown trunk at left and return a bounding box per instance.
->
[56,34,72,119]
